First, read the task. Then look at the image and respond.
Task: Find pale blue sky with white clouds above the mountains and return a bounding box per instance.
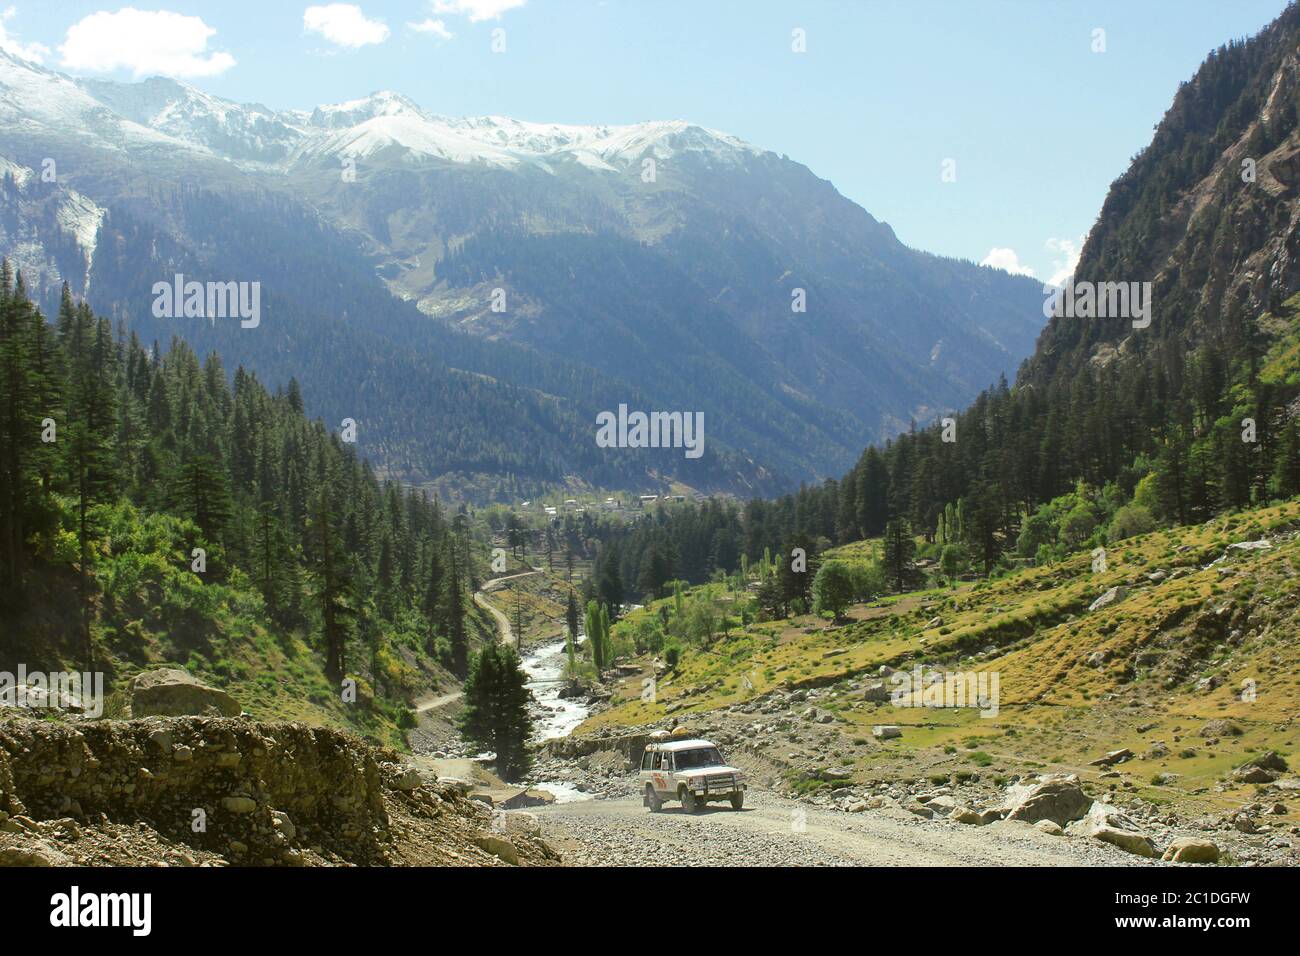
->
[0,0,1286,280]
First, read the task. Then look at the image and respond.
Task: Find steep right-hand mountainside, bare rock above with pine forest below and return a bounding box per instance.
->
[785,5,1300,561]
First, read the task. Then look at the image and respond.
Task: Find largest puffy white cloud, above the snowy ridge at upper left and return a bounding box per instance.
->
[59,7,235,77]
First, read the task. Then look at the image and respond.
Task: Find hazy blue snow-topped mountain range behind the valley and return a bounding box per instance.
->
[0,53,1041,497]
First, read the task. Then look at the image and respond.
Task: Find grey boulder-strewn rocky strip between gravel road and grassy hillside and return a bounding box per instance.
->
[534,691,1300,866]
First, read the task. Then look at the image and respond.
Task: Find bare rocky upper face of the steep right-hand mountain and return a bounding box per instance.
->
[1024,5,1300,385]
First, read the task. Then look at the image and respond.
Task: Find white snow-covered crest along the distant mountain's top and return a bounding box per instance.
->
[0,52,759,172]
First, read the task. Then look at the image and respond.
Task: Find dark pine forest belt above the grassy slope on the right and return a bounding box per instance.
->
[595,291,1300,606]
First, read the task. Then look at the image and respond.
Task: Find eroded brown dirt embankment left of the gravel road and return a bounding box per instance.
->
[0,717,555,866]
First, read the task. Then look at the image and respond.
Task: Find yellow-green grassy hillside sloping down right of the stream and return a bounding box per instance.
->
[590,502,1300,805]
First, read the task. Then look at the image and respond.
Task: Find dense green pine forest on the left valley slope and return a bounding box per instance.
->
[0,263,475,738]
